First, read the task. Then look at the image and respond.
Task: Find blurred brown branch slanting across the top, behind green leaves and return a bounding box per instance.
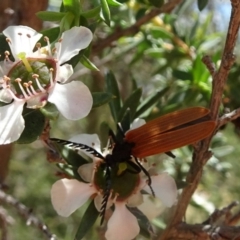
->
[92,0,182,55]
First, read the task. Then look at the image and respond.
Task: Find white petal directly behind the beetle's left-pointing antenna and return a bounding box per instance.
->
[69,134,101,157]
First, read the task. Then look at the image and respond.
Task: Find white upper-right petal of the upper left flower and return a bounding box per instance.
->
[57,27,93,65]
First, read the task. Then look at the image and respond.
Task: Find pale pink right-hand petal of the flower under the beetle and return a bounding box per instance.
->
[144,173,177,207]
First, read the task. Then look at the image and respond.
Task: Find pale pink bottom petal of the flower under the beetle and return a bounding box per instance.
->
[105,202,140,240]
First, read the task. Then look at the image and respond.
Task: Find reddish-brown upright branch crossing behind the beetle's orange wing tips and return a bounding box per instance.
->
[160,0,240,240]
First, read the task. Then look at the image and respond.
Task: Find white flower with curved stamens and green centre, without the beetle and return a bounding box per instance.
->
[0,26,93,144]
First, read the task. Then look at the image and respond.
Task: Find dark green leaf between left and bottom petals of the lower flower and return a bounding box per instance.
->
[74,200,99,240]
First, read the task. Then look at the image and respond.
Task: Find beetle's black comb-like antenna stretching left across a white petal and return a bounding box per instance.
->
[50,138,105,161]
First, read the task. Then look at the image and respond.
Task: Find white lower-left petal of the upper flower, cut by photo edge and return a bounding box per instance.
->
[0,101,25,145]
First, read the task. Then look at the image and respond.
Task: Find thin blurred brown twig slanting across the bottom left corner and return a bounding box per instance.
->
[0,190,57,240]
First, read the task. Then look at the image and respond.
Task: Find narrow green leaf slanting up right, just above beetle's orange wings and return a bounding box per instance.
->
[134,87,170,118]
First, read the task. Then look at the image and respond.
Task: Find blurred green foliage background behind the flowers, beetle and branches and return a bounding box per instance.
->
[0,0,240,240]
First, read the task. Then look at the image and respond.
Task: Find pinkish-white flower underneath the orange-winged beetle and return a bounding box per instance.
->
[51,134,177,240]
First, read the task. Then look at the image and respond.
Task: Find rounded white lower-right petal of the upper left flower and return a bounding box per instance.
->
[48,81,93,120]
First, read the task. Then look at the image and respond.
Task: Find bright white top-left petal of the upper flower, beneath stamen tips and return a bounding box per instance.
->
[3,26,42,60]
